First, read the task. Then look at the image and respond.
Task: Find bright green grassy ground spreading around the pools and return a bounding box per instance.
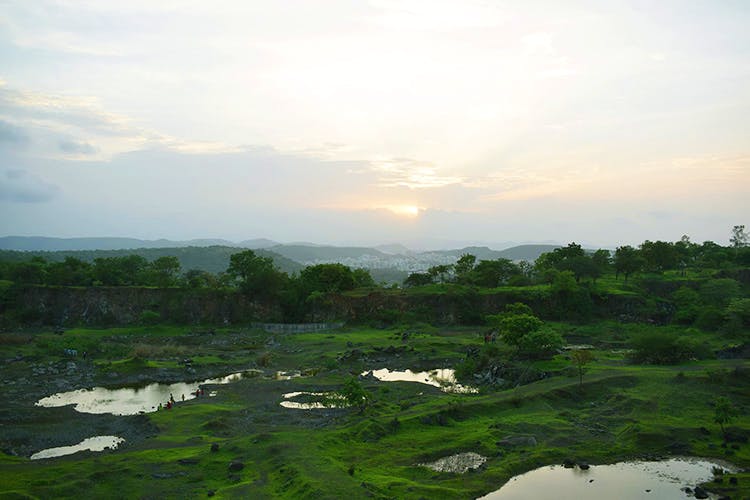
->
[0,323,750,498]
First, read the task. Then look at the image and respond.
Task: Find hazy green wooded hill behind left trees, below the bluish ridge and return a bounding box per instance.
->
[0,246,304,273]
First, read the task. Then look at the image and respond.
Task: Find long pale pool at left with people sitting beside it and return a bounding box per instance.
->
[36,373,248,415]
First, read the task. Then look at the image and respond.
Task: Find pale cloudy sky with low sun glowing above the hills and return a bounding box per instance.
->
[0,0,750,250]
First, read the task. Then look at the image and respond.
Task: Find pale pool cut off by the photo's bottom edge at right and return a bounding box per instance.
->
[480,458,736,500]
